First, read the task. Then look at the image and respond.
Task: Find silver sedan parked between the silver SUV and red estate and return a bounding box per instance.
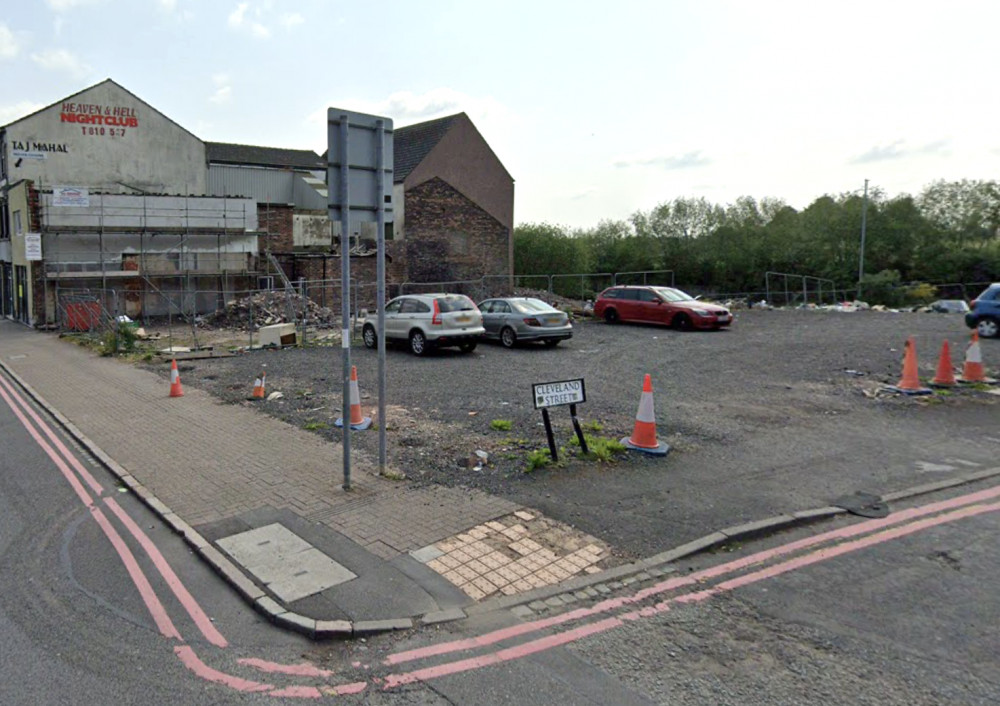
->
[479,297,573,348]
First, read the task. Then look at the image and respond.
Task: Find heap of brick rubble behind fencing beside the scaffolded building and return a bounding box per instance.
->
[198,290,340,330]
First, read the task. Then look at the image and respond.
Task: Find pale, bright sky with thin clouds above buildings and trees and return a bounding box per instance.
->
[0,0,1000,228]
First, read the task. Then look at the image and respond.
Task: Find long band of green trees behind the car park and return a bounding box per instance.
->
[514,180,1000,306]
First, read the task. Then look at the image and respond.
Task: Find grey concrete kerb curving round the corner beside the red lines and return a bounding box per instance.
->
[0,361,1000,639]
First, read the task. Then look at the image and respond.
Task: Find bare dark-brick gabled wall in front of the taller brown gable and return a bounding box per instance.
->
[403,178,510,282]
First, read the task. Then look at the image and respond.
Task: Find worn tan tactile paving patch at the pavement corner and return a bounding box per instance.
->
[410,509,612,601]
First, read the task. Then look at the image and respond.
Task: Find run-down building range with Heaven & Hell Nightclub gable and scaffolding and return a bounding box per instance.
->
[0,79,514,325]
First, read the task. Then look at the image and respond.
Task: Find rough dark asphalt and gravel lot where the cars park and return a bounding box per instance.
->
[168,310,1000,559]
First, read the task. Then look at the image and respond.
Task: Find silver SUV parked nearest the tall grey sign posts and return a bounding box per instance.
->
[361,294,486,355]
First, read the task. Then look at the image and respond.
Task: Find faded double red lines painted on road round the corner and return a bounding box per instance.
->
[0,366,1000,698]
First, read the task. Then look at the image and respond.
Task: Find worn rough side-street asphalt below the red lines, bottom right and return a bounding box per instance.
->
[571,496,1000,706]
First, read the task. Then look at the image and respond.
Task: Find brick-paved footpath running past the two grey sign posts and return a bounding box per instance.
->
[0,322,519,559]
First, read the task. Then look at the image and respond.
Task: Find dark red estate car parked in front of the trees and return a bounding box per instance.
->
[594,287,733,331]
